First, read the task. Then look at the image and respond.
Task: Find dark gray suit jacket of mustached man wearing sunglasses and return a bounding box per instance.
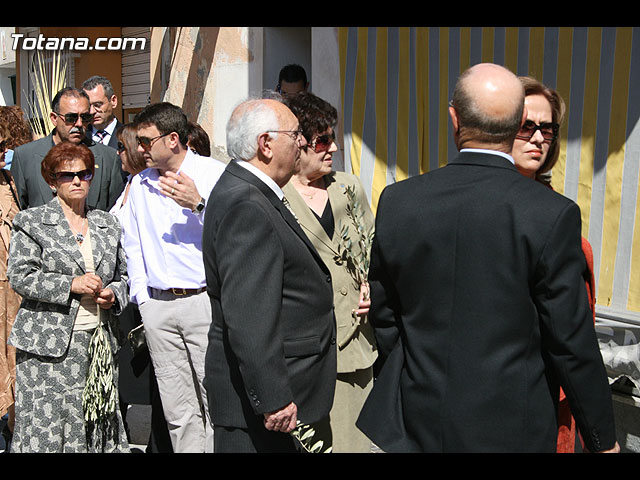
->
[11,133,125,211]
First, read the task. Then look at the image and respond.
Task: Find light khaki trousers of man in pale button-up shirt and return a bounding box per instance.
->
[140,290,213,453]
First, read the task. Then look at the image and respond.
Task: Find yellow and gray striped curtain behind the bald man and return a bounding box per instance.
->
[338,27,640,323]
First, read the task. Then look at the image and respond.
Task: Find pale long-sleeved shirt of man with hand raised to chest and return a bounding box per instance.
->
[120,150,225,305]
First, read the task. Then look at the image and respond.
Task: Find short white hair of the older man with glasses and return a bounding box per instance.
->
[227,99,280,161]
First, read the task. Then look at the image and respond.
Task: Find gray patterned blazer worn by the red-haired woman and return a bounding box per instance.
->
[7,198,128,357]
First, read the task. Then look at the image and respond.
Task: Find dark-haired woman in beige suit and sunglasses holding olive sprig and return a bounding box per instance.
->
[283,92,377,453]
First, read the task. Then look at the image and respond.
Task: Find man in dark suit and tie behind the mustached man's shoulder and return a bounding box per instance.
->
[82,75,122,148]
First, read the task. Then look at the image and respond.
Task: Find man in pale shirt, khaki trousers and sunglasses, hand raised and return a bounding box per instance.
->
[122,103,225,453]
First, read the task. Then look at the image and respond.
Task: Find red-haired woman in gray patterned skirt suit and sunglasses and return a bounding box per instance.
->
[7,142,129,452]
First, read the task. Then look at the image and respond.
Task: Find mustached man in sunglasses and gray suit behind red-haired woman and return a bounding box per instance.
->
[11,87,124,211]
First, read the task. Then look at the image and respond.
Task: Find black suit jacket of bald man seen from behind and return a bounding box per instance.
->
[357,152,616,452]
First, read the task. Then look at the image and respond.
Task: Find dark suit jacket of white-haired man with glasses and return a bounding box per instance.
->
[202,161,336,429]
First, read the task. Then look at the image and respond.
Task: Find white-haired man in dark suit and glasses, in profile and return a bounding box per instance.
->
[202,100,337,453]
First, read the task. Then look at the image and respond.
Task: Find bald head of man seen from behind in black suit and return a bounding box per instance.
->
[450,63,524,152]
